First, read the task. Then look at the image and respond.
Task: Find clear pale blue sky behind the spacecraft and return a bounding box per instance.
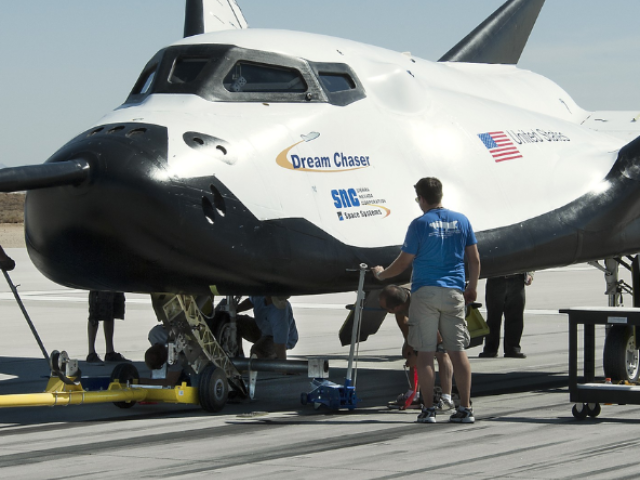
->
[0,0,640,166]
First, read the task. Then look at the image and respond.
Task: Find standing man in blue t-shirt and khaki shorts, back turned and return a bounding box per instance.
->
[373,177,480,423]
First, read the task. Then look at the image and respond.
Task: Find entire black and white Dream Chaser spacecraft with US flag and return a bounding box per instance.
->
[0,0,640,382]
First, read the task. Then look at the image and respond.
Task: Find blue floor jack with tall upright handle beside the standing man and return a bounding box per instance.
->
[300,263,369,410]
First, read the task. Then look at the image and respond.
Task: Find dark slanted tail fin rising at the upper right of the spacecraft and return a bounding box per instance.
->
[438,0,544,65]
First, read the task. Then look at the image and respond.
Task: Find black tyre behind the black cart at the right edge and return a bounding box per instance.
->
[602,325,640,383]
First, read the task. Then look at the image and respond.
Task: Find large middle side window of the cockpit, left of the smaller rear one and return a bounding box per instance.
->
[223,62,307,93]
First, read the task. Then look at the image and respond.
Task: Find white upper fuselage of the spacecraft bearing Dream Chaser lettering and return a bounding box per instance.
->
[100,29,625,247]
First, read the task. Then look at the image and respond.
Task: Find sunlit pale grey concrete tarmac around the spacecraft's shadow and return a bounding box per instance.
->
[0,248,640,480]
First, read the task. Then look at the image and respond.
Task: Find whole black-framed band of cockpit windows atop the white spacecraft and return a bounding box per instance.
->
[125,44,366,106]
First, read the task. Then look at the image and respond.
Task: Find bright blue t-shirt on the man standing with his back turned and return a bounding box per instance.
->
[402,208,478,292]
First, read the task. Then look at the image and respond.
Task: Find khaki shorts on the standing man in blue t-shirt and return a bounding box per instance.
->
[407,287,470,352]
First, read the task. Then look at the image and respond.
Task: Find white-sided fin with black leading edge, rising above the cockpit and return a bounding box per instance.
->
[184,0,249,38]
